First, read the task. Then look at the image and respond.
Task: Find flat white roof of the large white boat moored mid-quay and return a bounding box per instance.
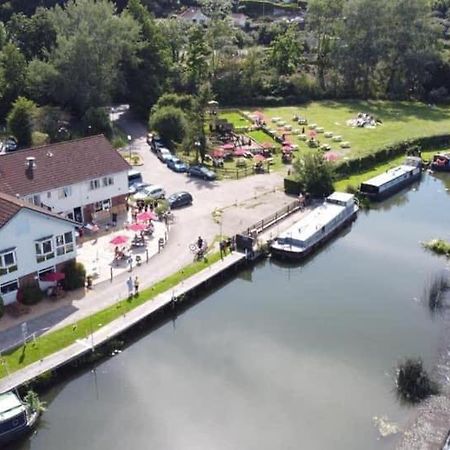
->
[279,202,345,242]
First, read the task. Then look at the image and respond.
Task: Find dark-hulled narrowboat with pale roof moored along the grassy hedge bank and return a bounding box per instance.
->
[359,156,422,200]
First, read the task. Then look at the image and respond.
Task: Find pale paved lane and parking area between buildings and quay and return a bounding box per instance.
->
[0,108,292,350]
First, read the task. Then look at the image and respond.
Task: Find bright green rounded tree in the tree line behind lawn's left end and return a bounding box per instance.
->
[269,27,302,75]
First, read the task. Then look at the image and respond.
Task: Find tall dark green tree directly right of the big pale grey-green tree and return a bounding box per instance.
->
[125,0,170,117]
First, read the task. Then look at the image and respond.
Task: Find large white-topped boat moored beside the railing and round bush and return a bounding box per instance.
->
[270,192,359,260]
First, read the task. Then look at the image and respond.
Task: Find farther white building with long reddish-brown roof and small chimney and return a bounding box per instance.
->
[0,135,130,223]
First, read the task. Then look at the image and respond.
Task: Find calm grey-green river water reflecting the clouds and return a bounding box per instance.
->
[9,175,450,450]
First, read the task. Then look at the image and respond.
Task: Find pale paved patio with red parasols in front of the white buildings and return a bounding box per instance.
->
[77,216,168,284]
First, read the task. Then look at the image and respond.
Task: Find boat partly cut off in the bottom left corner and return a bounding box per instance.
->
[0,392,40,448]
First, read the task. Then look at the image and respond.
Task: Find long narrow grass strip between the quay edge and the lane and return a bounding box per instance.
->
[0,252,220,378]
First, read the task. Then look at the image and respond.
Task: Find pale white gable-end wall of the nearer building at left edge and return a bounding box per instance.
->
[0,209,76,304]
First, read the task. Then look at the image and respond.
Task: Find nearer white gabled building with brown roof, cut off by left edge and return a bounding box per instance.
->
[0,193,76,305]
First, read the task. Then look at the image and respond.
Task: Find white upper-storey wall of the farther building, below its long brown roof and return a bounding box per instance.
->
[25,171,128,217]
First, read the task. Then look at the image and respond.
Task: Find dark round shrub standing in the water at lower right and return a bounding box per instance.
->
[397,358,439,403]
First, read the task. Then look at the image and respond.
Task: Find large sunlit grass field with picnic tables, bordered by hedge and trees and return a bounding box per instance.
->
[262,101,450,158]
